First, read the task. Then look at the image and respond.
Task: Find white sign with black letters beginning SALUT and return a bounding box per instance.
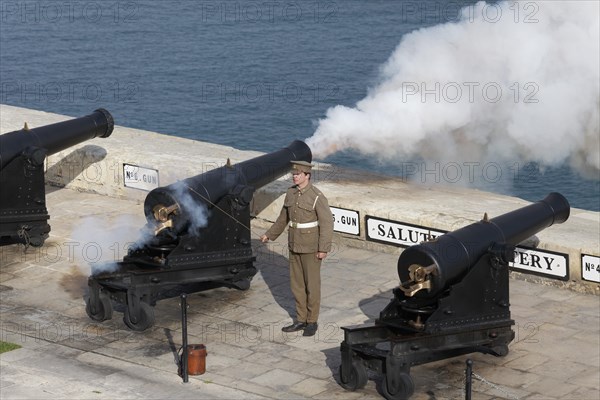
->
[366,216,446,247]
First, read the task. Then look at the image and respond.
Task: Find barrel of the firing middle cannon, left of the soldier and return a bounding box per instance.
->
[144,140,312,233]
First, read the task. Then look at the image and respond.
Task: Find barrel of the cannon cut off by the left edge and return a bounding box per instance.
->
[0,108,114,169]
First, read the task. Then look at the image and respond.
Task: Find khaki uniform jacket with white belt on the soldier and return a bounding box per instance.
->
[265,182,333,253]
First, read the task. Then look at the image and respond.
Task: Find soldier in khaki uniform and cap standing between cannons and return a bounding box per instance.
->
[260,161,333,336]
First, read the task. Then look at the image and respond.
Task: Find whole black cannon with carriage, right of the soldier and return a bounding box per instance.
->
[340,193,570,399]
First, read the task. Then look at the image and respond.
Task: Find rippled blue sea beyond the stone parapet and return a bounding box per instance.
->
[0,0,600,211]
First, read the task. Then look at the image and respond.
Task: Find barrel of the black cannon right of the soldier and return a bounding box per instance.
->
[398,193,570,298]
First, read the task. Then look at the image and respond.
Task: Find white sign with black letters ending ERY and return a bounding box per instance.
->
[511,247,569,280]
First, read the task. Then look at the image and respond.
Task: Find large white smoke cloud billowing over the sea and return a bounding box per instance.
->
[307,1,600,180]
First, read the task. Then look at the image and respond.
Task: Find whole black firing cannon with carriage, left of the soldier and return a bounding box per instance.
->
[86,140,312,331]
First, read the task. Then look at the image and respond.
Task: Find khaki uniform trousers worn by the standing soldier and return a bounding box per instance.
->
[290,251,322,323]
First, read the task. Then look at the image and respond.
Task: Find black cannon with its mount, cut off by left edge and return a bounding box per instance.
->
[0,108,114,246]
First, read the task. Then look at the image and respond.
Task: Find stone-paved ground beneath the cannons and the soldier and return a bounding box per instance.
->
[0,188,600,400]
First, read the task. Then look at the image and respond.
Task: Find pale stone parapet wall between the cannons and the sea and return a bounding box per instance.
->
[0,105,600,294]
